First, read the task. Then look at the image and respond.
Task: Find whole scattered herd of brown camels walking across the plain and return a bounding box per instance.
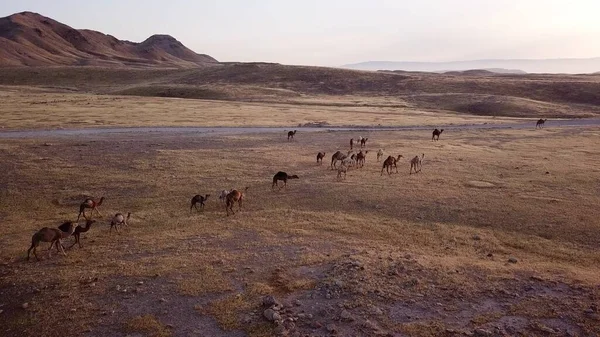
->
[27,119,547,261]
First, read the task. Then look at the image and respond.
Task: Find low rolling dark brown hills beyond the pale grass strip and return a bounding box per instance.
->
[0,63,600,118]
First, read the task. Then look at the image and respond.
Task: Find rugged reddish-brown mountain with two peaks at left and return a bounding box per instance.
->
[0,12,218,67]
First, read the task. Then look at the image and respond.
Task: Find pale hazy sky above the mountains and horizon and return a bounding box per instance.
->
[0,0,600,66]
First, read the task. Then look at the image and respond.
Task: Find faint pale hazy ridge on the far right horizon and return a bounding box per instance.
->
[341,57,600,74]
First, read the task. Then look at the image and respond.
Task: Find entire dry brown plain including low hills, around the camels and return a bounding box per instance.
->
[0,65,600,336]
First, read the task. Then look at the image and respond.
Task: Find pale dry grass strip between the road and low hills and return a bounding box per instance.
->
[0,87,522,129]
